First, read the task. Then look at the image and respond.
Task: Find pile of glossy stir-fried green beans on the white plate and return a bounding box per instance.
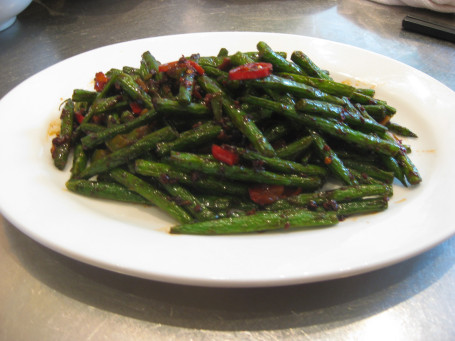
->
[51,42,422,234]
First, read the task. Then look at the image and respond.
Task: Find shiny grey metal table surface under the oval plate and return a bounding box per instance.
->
[0,0,455,341]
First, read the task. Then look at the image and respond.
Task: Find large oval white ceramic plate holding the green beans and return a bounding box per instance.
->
[0,32,455,287]
